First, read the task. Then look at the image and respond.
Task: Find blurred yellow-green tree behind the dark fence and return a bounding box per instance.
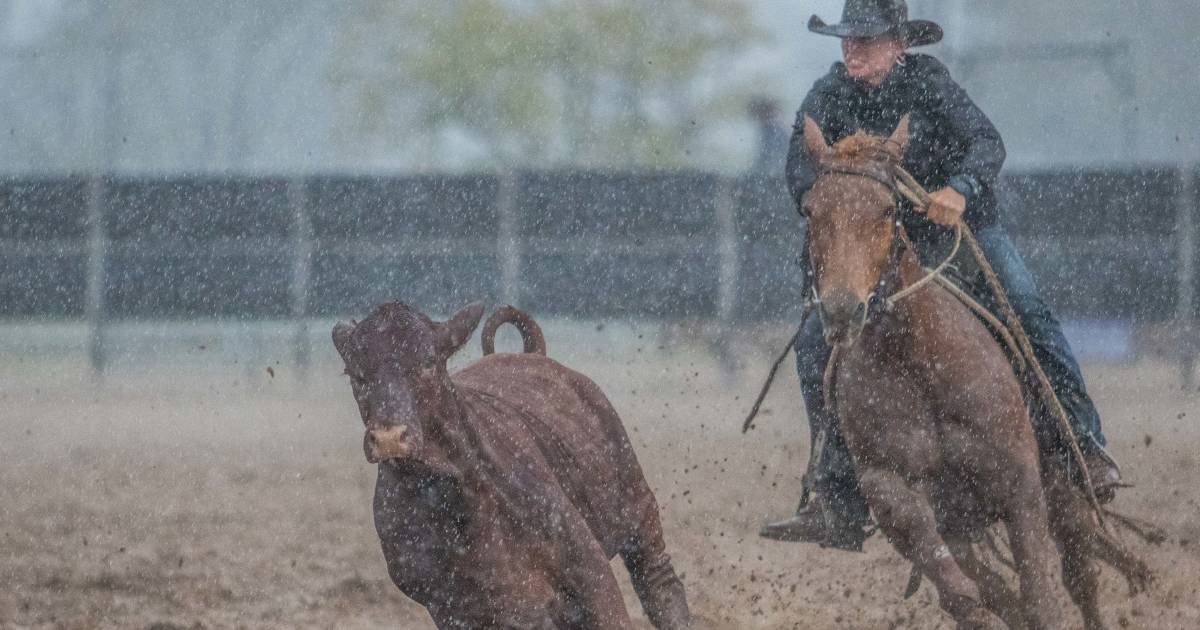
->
[332,0,762,167]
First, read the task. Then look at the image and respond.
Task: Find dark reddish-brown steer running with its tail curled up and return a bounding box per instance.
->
[334,304,689,629]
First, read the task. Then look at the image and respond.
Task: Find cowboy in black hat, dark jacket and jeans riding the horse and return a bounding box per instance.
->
[760,0,1121,551]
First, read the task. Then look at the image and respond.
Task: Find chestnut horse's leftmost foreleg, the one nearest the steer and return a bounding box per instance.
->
[859,468,1004,630]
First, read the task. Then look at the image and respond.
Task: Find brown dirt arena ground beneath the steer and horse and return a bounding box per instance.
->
[0,328,1200,630]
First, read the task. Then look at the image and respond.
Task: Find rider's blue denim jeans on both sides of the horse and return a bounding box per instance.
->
[796,226,1105,521]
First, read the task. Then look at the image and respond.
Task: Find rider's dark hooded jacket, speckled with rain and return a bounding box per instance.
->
[787,54,1004,238]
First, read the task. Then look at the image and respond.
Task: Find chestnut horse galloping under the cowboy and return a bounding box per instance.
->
[802,116,1150,630]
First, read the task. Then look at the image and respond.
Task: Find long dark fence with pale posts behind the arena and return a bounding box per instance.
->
[0,169,1200,372]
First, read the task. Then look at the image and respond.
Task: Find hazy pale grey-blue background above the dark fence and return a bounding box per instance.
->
[0,0,1200,174]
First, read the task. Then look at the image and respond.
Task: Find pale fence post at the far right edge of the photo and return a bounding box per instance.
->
[1175,164,1200,391]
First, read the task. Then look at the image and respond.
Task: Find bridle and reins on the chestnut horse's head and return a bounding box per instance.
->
[802,156,962,326]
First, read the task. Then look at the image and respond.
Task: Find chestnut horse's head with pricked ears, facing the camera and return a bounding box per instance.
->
[800,116,908,344]
